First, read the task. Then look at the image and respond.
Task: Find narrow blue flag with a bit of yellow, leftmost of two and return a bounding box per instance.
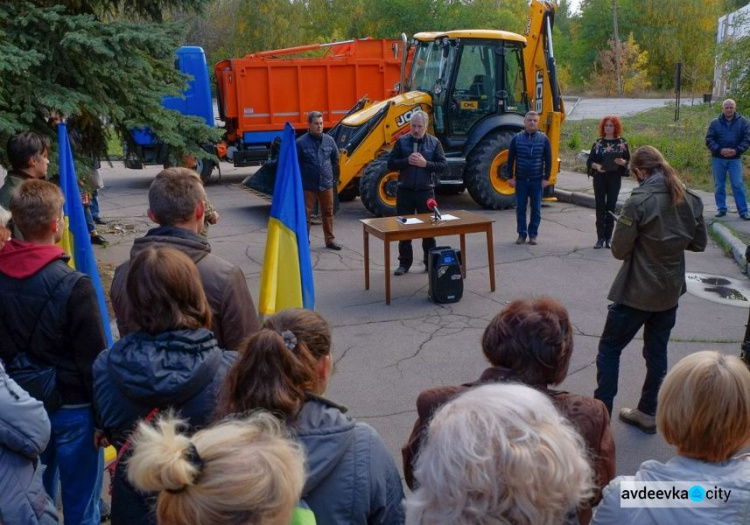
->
[57,122,112,346]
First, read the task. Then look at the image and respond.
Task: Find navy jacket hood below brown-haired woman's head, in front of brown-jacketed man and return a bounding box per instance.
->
[107,328,223,406]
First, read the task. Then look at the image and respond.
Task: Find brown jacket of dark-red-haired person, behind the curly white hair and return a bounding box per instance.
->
[401,367,615,523]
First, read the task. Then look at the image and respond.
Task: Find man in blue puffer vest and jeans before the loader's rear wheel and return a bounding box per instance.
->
[508,111,552,244]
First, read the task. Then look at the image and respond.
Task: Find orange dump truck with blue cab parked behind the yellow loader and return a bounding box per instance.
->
[126,38,403,181]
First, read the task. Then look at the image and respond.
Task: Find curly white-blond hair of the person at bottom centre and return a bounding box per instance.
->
[406,384,593,525]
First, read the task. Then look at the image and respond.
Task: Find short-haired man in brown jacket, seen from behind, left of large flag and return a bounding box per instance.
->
[110,168,260,350]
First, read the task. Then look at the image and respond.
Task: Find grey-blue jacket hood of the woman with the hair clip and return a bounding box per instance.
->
[293,395,356,497]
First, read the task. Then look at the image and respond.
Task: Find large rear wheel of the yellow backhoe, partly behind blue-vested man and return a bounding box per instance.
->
[464,131,516,210]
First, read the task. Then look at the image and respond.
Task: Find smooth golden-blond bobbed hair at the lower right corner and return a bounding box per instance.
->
[656,351,750,462]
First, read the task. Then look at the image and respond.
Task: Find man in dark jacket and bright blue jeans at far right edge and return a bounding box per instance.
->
[706,98,750,221]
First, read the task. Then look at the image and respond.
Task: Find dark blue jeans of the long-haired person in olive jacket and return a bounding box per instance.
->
[594,304,677,415]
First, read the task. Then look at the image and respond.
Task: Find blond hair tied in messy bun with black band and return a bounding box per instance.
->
[127,413,305,525]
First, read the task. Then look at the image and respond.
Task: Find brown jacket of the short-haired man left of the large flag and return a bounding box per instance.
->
[110,226,260,350]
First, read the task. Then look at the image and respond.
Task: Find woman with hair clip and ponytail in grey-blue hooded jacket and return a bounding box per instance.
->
[217,309,404,525]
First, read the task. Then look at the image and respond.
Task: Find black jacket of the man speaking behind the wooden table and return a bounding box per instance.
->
[388,134,448,190]
